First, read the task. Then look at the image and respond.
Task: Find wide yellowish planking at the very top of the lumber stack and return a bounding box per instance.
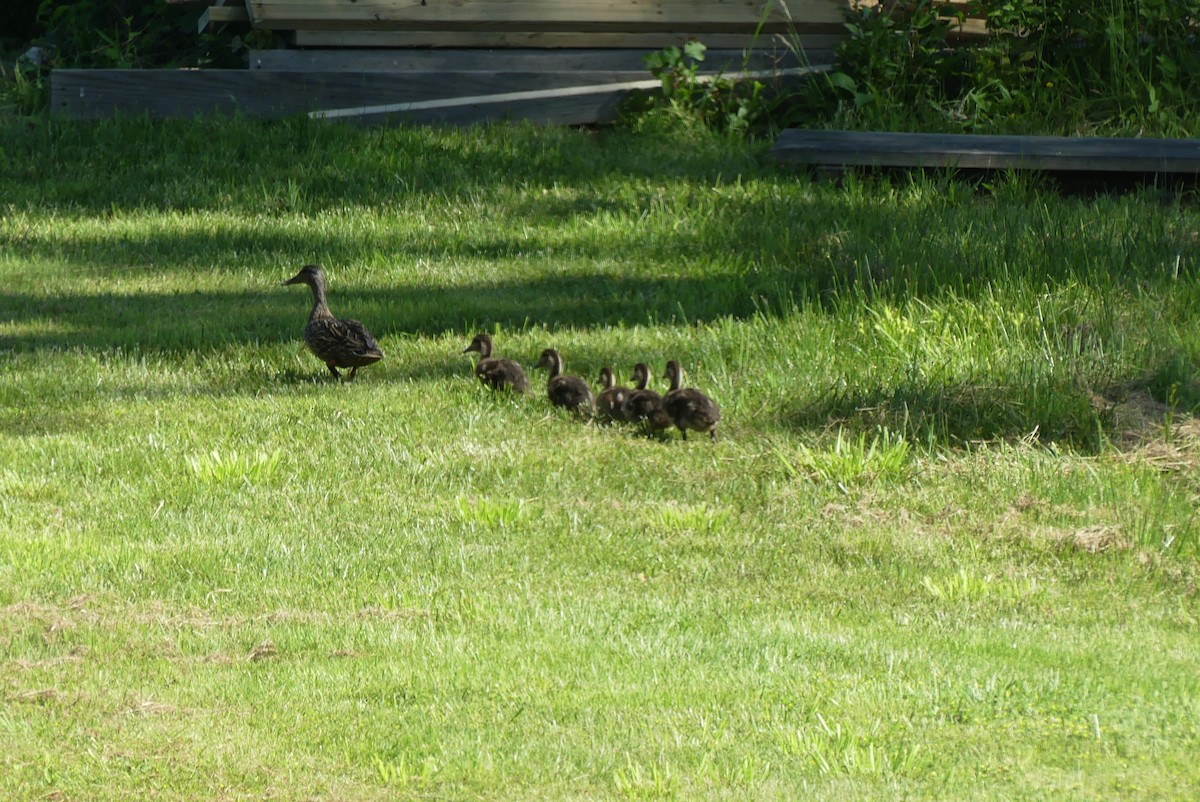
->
[248,0,847,32]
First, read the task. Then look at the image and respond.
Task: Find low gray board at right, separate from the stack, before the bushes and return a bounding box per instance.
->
[772,128,1200,174]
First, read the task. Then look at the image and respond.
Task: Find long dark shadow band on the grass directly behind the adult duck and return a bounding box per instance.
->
[0,267,816,353]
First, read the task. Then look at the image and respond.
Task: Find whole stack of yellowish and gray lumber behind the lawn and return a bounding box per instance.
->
[52,0,979,124]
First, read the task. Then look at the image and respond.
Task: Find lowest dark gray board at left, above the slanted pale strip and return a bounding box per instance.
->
[50,70,647,122]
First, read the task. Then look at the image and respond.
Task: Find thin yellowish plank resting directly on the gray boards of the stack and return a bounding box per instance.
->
[289,29,841,52]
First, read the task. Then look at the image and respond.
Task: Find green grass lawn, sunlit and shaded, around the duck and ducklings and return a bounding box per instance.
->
[0,120,1200,800]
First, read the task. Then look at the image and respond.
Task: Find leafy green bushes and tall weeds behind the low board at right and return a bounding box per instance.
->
[803,0,1200,136]
